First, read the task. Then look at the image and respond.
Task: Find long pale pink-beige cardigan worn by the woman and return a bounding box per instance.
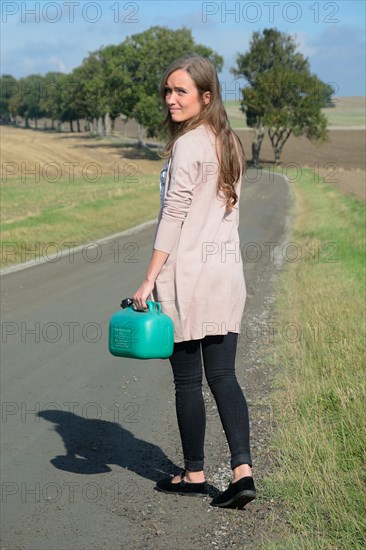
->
[153,125,246,342]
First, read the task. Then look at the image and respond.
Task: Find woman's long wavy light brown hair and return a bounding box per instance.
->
[160,55,245,210]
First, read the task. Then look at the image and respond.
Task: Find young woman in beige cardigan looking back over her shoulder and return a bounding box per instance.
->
[133,56,255,508]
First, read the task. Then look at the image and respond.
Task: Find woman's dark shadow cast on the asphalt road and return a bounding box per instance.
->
[37,410,179,481]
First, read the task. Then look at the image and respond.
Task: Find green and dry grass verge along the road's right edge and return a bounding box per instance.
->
[265,170,366,550]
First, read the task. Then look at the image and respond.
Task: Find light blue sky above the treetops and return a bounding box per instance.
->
[1,0,365,99]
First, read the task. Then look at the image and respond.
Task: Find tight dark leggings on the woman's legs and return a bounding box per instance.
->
[169,332,252,472]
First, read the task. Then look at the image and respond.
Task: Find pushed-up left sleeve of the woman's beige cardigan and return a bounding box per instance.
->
[153,134,199,254]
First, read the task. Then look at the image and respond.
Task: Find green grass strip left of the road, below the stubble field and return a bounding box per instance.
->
[1,175,159,268]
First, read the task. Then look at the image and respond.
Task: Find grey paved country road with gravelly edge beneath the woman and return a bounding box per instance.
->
[1,170,291,550]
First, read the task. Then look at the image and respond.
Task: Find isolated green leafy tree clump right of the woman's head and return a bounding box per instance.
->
[231,29,332,165]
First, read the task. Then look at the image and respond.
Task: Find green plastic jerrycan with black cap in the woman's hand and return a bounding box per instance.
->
[109,298,174,359]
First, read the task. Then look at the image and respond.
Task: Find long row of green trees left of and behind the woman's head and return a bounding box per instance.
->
[1,26,223,137]
